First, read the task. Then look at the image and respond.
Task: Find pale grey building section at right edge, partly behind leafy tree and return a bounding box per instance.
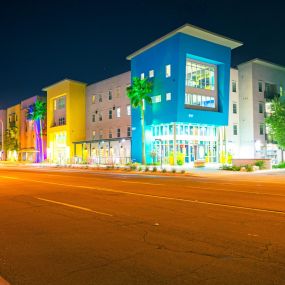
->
[238,59,285,162]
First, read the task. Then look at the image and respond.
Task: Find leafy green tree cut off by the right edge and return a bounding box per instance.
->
[266,98,285,160]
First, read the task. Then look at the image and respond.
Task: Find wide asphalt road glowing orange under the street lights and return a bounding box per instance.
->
[0,167,285,285]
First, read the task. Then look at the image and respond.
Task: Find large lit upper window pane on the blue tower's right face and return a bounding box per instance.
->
[186,59,215,90]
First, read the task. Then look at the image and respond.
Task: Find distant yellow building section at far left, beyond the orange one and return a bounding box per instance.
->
[6,104,21,161]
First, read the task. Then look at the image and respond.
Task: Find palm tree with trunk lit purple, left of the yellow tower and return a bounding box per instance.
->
[26,99,47,161]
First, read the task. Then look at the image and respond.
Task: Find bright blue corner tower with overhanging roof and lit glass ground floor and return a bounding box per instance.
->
[128,25,242,163]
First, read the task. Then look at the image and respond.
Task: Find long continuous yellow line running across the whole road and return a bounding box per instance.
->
[0,176,285,215]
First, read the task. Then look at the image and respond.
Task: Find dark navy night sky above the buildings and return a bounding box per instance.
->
[0,0,285,109]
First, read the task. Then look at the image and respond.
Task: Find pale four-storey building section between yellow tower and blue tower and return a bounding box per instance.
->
[79,72,131,163]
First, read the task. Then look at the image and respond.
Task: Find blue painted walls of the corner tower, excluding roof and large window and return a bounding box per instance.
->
[131,33,231,162]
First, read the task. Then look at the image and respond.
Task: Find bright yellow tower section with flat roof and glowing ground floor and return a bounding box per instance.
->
[43,79,86,164]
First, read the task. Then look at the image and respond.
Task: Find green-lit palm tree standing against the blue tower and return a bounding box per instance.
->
[127,77,153,164]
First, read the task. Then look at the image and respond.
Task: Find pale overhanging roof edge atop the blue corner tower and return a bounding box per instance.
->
[127,23,243,60]
